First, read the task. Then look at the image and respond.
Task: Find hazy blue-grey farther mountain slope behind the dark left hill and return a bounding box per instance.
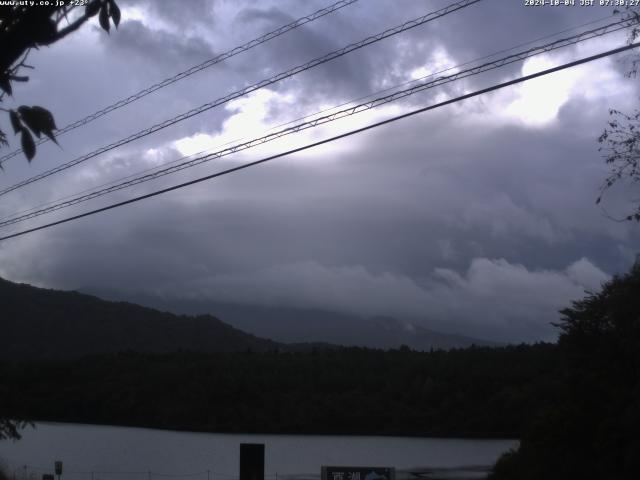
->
[86,289,499,350]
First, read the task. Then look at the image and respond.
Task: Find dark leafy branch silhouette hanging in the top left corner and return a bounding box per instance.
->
[0,0,120,161]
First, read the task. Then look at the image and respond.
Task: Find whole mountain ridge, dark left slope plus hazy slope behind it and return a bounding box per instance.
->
[0,278,496,360]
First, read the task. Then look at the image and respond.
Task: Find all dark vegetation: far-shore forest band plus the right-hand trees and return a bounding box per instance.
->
[5,262,640,480]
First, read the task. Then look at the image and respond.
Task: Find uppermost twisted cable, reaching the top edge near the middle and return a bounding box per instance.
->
[0,0,358,166]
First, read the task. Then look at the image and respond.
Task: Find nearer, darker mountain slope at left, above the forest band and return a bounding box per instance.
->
[0,279,283,359]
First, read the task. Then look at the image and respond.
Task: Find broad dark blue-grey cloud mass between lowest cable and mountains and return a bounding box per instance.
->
[1,88,637,340]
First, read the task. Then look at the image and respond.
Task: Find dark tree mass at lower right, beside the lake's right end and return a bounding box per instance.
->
[493,262,640,480]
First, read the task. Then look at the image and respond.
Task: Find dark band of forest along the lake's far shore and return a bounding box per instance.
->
[0,344,559,438]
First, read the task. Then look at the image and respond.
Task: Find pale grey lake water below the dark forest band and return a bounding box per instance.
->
[0,423,517,480]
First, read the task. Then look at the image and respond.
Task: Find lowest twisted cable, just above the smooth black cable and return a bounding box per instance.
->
[0,15,638,227]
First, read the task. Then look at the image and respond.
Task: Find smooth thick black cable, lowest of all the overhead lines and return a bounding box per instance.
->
[0,42,640,241]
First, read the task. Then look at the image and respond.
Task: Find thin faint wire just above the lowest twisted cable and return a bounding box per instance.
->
[0,10,616,227]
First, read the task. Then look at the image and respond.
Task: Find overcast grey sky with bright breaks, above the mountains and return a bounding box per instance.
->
[0,0,640,341]
